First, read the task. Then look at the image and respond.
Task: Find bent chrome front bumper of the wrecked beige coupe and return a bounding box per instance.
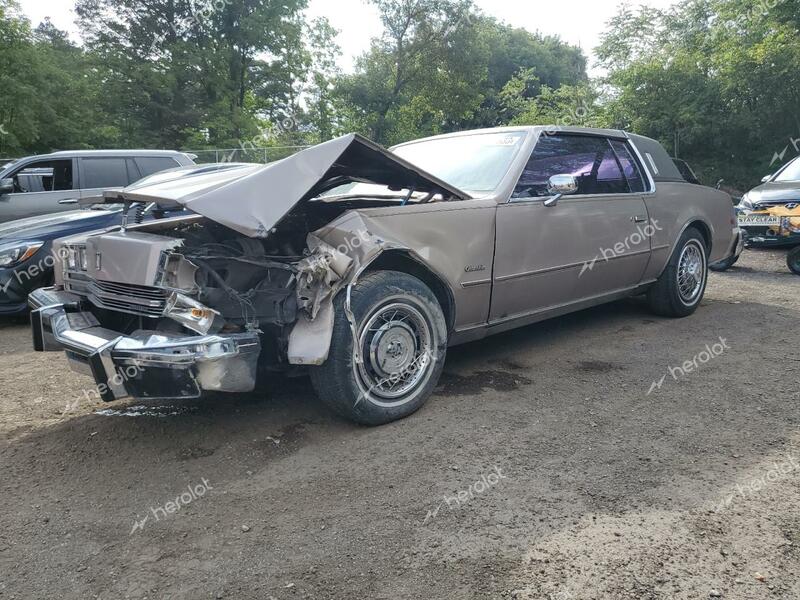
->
[28,288,261,402]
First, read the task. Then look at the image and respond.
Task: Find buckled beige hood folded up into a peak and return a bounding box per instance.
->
[105,134,469,237]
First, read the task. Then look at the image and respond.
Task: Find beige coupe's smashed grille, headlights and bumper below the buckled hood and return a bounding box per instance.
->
[34,221,364,401]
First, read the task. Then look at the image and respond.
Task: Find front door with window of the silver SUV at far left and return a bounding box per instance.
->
[0,158,80,222]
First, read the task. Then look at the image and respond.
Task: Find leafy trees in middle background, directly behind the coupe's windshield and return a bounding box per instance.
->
[337,0,588,144]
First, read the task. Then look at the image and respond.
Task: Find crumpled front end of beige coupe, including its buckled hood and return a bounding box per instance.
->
[30,135,469,400]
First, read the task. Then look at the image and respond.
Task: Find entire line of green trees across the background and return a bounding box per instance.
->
[0,0,800,189]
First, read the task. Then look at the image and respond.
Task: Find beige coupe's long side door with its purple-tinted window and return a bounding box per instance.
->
[490,133,652,322]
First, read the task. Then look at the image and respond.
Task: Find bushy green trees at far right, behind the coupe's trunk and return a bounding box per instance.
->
[598,0,800,190]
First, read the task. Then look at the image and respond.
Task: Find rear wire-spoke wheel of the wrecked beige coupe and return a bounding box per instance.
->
[647,227,708,317]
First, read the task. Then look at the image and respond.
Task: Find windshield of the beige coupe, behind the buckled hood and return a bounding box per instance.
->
[322,131,526,198]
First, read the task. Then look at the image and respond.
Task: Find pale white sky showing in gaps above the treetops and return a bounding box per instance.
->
[19,0,677,73]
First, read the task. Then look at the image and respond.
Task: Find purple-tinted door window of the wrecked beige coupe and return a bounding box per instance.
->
[513,135,629,198]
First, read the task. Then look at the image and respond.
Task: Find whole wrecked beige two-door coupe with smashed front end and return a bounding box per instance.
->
[29,127,741,425]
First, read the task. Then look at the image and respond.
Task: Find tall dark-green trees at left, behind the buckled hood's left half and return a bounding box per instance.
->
[76,0,306,147]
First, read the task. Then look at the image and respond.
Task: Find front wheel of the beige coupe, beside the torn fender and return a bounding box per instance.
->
[311,271,447,425]
